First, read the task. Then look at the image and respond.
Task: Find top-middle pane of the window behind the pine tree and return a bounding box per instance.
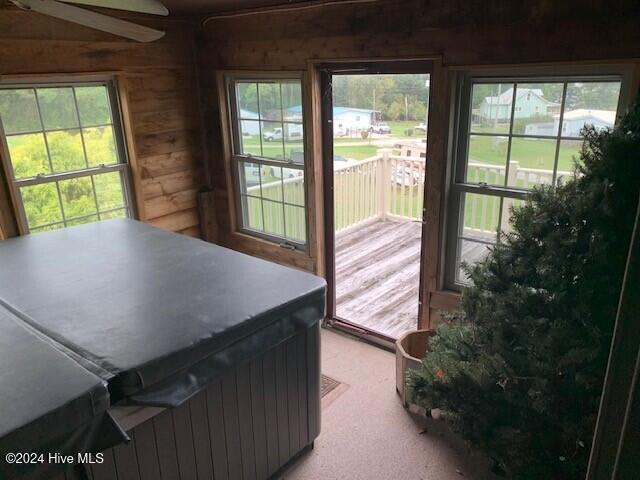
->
[513,83,563,136]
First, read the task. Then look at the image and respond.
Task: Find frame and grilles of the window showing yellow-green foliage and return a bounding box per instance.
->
[0,76,137,235]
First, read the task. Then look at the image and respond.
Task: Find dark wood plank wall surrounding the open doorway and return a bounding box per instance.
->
[198,0,640,326]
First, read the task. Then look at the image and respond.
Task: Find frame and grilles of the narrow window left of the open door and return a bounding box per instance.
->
[223,72,311,253]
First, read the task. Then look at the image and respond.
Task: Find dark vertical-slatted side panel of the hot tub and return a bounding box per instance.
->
[57,323,320,480]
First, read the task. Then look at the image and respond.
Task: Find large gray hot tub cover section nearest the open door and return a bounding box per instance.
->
[0,220,326,406]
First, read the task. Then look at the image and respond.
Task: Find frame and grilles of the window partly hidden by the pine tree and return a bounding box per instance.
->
[441,64,633,292]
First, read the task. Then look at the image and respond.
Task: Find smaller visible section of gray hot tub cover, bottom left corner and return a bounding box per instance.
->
[0,306,123,479]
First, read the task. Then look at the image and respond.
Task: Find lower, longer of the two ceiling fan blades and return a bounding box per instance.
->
[12,0,164,42]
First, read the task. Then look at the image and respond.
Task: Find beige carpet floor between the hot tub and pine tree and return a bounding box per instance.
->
[282,330,476,480]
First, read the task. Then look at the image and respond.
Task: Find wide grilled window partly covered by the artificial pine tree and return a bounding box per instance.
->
[445,76,621,288]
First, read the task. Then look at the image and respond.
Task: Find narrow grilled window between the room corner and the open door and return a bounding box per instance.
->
[227,76,307,248]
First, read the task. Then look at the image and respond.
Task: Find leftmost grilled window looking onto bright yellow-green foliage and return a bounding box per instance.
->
[0,82,131,233]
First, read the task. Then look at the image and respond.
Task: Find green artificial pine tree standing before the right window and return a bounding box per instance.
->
[407,99,640,480]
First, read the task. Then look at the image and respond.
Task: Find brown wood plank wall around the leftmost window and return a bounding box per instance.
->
[0,8,206,237]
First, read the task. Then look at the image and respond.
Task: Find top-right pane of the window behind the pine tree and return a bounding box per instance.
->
[562,82,620,137]
